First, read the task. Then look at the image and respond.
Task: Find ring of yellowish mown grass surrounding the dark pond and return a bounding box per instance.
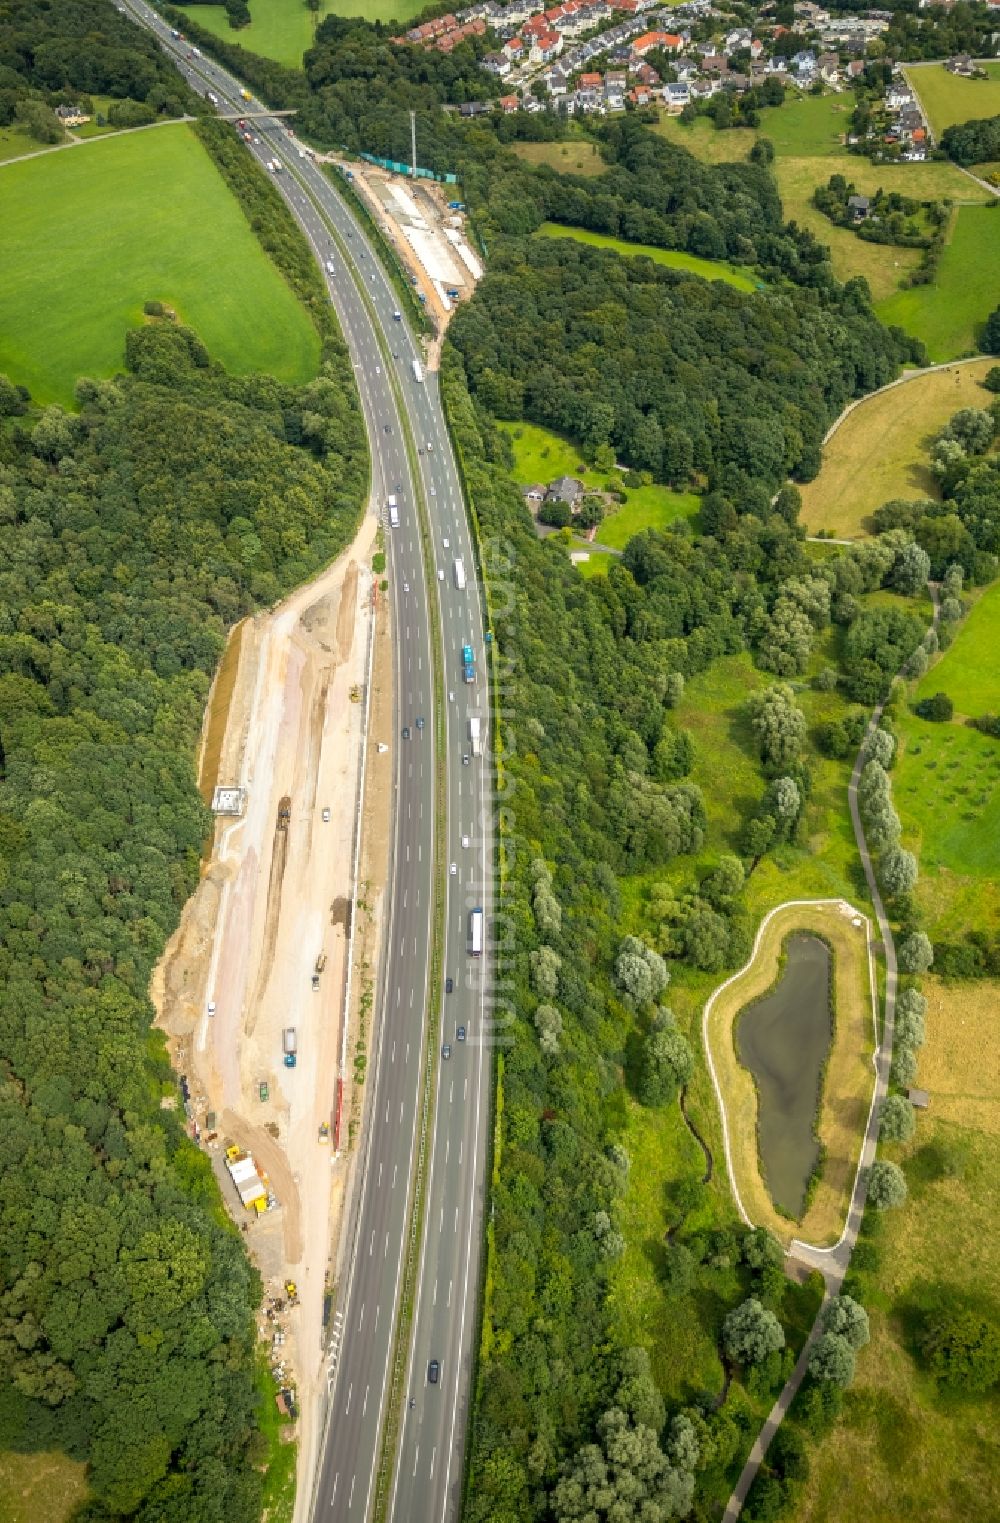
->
[705,903,875,1246]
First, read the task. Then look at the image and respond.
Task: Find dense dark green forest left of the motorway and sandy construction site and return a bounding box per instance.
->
[0,320,367,1523]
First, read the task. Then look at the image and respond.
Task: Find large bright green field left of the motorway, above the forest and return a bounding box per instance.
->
[0,125,320,404]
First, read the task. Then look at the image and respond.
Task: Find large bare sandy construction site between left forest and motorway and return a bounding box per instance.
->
[152,515,393,1498]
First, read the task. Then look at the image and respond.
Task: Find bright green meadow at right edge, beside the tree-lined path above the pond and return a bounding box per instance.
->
[893,583,1000,938]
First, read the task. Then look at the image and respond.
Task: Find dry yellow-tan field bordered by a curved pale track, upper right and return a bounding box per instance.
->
[801,359,995,539]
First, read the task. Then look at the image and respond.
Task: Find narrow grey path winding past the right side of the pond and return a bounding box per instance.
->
[709,583,939,1523]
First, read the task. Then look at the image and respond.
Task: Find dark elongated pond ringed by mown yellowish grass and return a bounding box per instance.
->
[735,934,833,1218]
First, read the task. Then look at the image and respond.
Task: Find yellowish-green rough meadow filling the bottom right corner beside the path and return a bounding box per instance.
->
[795,978,1000,1523]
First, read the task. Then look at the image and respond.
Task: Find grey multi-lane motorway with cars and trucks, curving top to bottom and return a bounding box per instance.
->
[123,0,492,1523]
